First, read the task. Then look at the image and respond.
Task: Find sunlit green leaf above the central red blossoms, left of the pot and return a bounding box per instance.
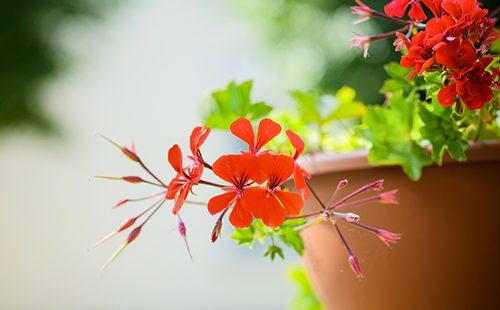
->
[204,81,273,129]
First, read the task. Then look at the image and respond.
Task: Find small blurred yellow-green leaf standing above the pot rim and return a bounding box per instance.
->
[323,86,366,123]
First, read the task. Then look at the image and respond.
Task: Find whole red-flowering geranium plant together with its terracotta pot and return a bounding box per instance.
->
[95,0,500,309]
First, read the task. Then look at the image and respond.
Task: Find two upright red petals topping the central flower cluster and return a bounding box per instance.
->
[230,118,281,155]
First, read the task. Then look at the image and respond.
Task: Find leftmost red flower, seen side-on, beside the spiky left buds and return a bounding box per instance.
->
[166,144,203,214]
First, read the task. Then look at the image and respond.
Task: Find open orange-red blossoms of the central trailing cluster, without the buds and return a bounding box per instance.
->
[167,118,307,227]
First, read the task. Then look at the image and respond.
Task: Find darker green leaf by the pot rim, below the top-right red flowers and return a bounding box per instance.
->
[419,99,468,165]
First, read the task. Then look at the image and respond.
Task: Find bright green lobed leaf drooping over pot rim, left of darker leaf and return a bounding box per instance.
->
[362,91,431,180]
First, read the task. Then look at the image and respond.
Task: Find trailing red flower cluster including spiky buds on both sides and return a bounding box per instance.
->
[98,118,401,277]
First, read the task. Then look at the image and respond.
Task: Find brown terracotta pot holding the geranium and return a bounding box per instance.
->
[303,142,500,310]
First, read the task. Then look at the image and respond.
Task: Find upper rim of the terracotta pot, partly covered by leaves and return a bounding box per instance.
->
[302,140,500,175]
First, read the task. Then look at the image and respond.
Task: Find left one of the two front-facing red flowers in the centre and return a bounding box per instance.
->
[208,154,256,227]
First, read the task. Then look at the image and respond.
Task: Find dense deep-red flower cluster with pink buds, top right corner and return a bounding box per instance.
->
[353,0,499,110]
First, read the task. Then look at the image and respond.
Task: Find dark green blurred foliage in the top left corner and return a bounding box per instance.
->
[0,0,112,133]
